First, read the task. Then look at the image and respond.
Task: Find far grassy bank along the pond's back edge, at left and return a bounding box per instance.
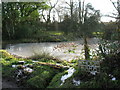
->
[2,31,67,48]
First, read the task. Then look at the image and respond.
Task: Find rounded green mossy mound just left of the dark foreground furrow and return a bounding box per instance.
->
[27,65,59,88]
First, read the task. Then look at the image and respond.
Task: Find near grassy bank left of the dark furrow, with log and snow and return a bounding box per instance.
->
[0,50,70,88]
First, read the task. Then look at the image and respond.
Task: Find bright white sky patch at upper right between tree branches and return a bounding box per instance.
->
[86,0,117,22]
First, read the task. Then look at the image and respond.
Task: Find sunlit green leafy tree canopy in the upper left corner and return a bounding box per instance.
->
[2,2,49,39]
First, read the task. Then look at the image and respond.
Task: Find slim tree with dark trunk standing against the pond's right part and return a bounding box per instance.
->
[78,0,100,59]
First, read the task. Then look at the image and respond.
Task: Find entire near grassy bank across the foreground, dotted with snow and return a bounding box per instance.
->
[0,50,120,88]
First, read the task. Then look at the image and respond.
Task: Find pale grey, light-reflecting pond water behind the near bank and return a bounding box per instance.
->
[6,38,99,61]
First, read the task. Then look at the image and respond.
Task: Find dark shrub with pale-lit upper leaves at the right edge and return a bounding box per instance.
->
[99,40,120,79]
